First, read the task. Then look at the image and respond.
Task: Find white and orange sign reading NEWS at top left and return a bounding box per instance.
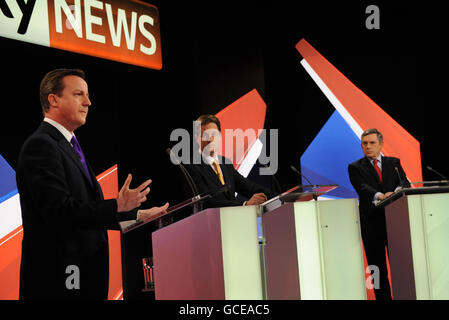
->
[0,0,162,70]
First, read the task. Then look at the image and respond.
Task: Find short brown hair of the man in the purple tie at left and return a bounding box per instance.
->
[40,69,86,114]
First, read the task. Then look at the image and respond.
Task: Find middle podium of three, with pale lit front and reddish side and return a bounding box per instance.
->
[262,197,366,300]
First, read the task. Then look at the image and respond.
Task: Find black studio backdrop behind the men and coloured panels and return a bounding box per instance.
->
[0,1,449,298]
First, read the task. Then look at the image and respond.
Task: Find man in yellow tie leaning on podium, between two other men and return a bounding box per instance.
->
[186,114,277,208]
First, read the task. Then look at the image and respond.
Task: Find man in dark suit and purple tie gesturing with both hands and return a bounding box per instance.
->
[16,69,168,299]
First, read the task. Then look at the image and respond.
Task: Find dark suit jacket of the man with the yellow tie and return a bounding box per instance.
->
[185,157,277,209]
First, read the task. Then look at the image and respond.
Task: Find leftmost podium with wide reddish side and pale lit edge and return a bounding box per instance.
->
[152,206,263,300]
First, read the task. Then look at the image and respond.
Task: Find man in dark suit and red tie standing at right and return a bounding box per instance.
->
[348,128,410,300]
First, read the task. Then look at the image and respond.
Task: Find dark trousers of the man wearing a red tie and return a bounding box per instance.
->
[363,236,392,300]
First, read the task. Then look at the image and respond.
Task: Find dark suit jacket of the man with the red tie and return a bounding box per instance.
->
[348,157,410,238]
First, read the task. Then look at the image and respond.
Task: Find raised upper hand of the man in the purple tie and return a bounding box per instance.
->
[117,174,151,212]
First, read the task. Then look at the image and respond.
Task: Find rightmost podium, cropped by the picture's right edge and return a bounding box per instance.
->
[378,186,449,300]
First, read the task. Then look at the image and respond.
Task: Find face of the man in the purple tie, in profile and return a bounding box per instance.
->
[53,75,91,132]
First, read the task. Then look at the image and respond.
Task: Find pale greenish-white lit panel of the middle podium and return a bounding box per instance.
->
[294,199,366,299]
